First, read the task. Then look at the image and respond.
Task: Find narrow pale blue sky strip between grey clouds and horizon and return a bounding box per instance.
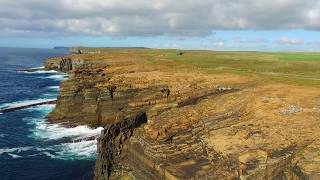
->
[0,30,320,51]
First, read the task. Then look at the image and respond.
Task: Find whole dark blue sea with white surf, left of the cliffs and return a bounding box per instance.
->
[0,48,101,180]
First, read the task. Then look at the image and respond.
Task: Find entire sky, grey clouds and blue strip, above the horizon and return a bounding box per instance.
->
[0,0,320,51]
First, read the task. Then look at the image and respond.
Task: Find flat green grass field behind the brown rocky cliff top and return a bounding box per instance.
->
[75,48,320,86]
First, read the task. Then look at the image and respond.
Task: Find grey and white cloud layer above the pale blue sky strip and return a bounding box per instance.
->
[0,0,320,37]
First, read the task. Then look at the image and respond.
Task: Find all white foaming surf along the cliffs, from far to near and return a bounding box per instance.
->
[0,67,103,160]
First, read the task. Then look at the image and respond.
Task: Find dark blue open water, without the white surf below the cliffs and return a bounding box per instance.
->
[0,48,94,179]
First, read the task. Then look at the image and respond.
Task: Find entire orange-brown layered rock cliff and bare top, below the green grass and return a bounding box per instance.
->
[46,51,320,179]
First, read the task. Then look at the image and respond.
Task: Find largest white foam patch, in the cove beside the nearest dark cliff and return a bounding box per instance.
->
[24,105,103,160]
